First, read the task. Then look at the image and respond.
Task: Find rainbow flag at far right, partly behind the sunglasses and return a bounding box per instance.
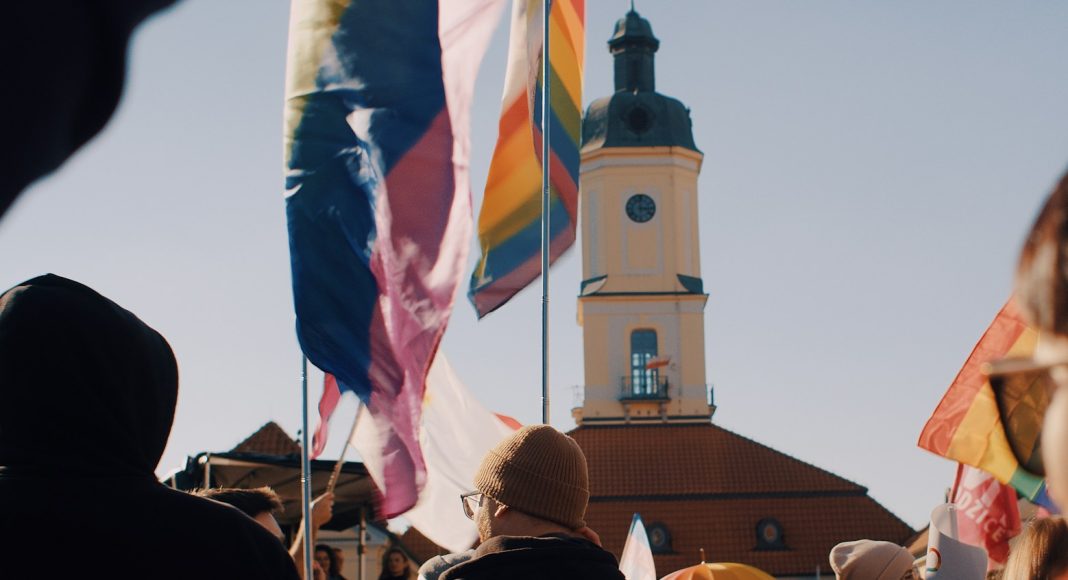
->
[917,300,1056,511]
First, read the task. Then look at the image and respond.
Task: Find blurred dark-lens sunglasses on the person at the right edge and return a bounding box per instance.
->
[983,358,1068,476]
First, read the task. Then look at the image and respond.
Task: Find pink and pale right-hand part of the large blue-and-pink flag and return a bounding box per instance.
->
[367,0,502,518]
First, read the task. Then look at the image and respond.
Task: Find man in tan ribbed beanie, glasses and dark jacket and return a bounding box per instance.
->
[435,425,624,580]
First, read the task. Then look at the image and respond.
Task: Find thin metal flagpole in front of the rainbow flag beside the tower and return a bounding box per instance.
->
[541,0,552,425]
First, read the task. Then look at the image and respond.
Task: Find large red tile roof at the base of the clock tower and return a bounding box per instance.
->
[570,424,913,576]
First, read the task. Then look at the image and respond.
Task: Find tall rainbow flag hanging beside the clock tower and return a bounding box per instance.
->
[468,0,585,317]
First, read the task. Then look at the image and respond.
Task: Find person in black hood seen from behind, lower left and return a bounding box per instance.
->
[0,275,298,579]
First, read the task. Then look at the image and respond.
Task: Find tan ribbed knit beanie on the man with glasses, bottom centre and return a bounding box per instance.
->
[474,425,590,530]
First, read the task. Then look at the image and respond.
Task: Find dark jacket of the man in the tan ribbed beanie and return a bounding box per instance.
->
[441,534,624,580]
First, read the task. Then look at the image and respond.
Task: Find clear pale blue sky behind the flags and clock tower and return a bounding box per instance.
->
[0,0,1068,527]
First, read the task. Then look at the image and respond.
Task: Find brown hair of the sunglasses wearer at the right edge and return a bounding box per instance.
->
[1016,174,1068,335]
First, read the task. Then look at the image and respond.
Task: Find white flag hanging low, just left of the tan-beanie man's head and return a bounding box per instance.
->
[351,349,515,552]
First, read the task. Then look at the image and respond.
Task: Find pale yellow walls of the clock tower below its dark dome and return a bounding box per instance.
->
[575,142,711,423]
